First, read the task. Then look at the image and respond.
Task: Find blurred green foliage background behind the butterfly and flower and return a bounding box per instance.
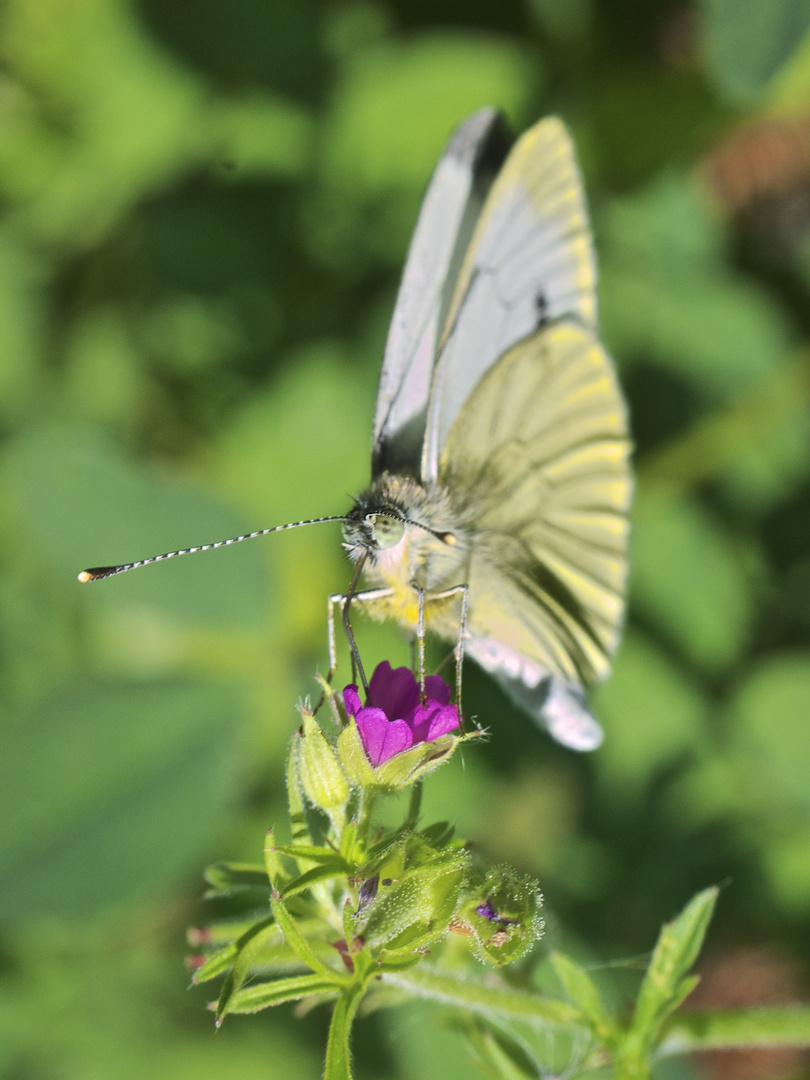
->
[0,0,810,1080]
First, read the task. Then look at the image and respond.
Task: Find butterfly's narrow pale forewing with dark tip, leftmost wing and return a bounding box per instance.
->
[372,109,511,476]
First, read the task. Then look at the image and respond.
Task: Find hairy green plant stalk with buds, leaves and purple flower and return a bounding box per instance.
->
[190,663,810,1080]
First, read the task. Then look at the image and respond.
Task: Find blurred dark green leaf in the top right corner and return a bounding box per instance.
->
[701,0,810,105]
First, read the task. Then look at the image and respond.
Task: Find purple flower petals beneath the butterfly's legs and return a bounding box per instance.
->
[343,660,459,766]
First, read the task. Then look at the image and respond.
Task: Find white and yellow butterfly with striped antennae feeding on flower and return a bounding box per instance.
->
[80,108,633,751]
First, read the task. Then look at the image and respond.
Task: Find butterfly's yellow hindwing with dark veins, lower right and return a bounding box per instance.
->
[440,323,632,687]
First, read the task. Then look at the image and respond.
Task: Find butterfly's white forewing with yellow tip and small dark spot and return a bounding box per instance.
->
[421,117,597,481]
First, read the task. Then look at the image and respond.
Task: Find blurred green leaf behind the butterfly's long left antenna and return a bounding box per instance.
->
[5,426,268,630]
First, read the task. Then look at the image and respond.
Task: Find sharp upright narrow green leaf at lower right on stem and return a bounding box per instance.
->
[631,887,719,1047]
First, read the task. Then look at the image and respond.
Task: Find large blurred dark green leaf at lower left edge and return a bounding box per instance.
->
[0,680,241,919]
